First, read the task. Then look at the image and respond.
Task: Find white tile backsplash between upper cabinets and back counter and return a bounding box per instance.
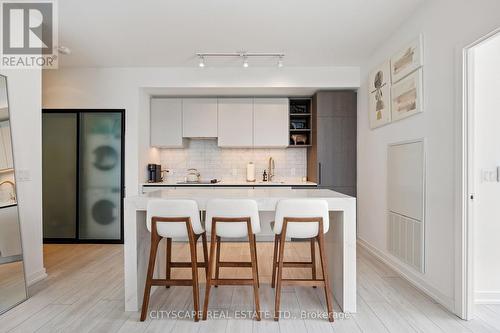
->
[160,139,307,181]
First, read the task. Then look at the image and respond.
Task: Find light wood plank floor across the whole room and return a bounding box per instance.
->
[0,243,500,333]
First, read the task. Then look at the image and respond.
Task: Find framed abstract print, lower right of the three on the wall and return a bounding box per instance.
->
[391,68,423,121]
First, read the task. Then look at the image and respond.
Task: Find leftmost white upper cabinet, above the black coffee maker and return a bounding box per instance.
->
[150,98,184,148]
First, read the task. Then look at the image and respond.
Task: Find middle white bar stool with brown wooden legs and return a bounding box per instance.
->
[203,199,260,320]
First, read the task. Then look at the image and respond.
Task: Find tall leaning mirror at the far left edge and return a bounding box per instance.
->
[0,75,28,314]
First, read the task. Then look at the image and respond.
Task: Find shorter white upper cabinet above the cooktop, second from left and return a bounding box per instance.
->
[182,98,217,138]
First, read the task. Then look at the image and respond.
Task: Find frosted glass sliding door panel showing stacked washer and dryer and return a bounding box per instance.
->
[79,112,122,240]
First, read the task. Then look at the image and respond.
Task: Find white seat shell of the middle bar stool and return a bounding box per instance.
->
[205,199,260,238]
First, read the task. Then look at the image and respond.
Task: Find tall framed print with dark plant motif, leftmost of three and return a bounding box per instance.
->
[368,61,391,129]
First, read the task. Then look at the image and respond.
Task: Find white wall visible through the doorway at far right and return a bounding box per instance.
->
[472,34,500,303]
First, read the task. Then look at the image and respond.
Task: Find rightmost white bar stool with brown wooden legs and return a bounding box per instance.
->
[271,199,333,321]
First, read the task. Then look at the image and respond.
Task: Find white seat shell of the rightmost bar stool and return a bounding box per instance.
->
[272,199,330,238]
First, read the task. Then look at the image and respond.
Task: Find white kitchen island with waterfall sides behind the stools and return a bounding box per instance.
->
[124,188,356,313]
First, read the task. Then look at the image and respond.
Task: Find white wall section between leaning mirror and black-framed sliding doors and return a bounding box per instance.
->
[0,69,46,284]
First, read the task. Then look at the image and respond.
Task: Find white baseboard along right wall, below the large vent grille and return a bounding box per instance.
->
[358,238,455,313]
